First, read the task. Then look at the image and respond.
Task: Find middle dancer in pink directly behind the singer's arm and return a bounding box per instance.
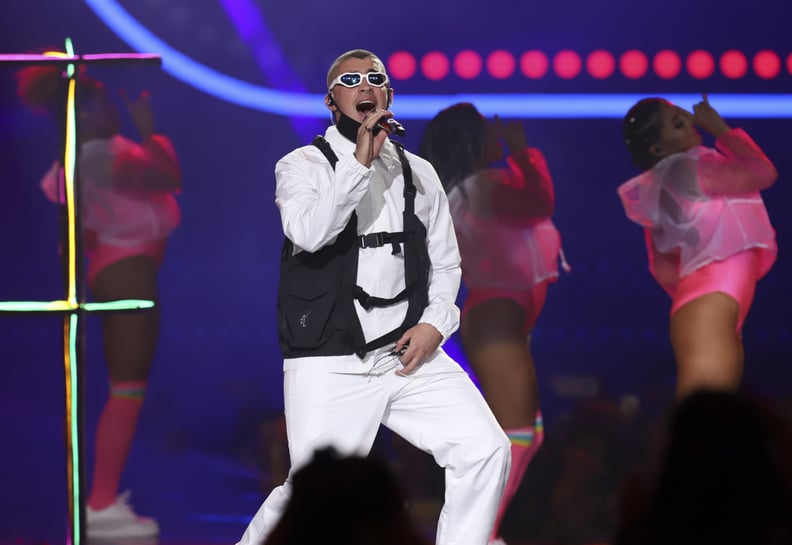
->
[421,103,561,543]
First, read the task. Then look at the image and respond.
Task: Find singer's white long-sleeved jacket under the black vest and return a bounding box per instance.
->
[275,126,461,371]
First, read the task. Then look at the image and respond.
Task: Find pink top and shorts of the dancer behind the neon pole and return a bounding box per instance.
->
[41,135,181,283]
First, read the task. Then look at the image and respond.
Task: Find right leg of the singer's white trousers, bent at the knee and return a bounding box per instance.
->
[382,351,511,545]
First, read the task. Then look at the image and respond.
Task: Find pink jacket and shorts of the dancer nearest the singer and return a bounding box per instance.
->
[448,148,561,331]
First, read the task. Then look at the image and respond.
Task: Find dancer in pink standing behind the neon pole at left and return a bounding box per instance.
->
[17,62,181,538]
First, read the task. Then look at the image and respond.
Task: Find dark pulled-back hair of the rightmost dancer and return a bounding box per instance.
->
[622,97,669,170]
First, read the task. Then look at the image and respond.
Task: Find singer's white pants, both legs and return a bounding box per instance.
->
[238,350,511,545]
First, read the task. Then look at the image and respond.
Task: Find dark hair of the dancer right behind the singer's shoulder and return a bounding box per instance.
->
[418,102,487,193]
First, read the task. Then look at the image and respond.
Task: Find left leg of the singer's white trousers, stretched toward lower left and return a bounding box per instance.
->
[238,369,388,545]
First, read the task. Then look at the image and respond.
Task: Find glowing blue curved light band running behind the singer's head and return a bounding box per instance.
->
[85,0,792,119]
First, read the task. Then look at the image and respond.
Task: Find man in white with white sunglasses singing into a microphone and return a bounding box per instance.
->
[234,49,510,545]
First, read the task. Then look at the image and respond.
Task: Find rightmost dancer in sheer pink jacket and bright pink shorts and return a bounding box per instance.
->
[618,95,777,398]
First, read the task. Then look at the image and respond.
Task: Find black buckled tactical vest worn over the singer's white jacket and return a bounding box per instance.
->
[278,136,430,358]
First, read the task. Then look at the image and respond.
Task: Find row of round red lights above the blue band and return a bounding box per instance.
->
[386,49,792,81]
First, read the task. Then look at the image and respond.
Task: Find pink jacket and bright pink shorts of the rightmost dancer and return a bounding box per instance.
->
[618,129,777,330]
